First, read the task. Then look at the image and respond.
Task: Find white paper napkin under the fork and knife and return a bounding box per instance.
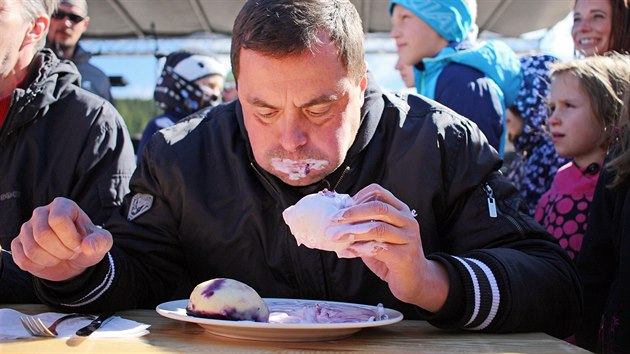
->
[0,309,150,340]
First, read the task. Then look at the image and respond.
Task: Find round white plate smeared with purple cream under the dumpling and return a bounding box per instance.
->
[156,298,403,342]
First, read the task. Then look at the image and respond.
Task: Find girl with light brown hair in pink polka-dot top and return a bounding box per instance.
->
[535,54,630,261]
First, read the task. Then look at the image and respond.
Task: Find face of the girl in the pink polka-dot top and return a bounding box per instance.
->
[547,73,606,167]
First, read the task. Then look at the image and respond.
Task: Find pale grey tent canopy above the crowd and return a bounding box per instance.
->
[84,0,573,39]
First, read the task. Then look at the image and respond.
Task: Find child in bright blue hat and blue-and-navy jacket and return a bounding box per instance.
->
[389,0,521,154]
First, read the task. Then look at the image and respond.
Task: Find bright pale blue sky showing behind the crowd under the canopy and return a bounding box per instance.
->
[81,14,573,99]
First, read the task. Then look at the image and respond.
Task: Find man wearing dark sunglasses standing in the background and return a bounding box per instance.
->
[47,0,114,103]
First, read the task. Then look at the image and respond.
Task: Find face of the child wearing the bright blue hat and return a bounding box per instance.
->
[389,5,448,65]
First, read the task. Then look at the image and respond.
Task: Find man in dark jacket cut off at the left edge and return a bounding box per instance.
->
[0,0,135,303]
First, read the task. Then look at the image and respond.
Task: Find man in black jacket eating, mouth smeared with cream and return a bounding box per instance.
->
[12,0,581,336]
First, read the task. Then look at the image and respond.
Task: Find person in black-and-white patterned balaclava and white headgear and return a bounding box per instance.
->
[137,50,227,164]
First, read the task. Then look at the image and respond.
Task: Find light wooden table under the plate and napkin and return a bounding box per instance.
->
[0,305,588,354]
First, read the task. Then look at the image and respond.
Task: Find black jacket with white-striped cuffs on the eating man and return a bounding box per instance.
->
[39,74,581,336]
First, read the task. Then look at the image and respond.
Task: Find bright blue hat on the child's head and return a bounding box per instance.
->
[389,0,473,42]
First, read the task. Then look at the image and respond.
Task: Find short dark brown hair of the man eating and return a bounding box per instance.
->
[231,0,365,83]
